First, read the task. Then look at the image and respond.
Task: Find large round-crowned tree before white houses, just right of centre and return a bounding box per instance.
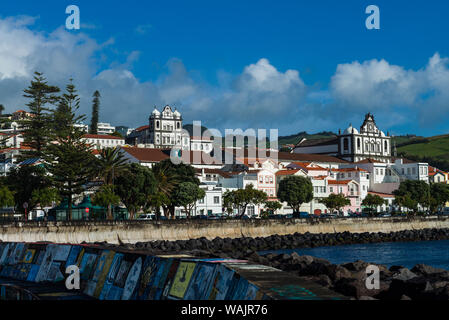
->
[277,176,313,212]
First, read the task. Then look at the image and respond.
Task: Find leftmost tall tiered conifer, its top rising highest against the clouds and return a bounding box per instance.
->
[21,72,60,159]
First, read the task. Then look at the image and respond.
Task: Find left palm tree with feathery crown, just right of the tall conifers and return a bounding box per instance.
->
[96,148,127,220]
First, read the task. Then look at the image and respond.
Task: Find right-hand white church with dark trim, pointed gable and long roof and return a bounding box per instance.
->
[293,113,392,163]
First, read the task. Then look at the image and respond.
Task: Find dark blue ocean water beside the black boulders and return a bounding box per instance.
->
[259,240,449,270]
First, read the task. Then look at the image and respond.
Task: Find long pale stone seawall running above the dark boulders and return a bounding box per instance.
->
[0,216,449,244]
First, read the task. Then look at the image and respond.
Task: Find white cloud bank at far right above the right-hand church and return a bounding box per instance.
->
[330,53,449,126]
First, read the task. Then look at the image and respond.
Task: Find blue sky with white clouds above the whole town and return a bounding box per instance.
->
[0,0,449,136]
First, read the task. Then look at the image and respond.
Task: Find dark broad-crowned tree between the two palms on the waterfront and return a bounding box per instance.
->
[115,163,160,219]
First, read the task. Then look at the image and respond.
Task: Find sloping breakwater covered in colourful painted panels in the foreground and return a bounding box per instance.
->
[0,243,344,300]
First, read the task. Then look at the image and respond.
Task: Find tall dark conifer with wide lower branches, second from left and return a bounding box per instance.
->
[45,82,95,220]
